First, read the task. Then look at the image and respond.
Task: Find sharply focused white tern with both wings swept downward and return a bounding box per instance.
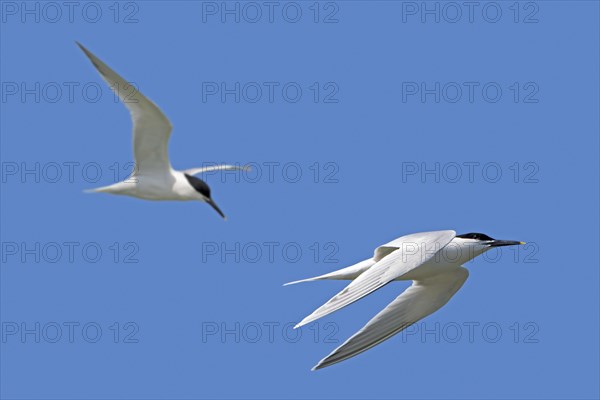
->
[284,230,525,371]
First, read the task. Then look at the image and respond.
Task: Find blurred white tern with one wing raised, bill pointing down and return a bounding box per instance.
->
[76,42,248,219]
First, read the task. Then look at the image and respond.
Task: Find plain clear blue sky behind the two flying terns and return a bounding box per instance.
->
[0,1,600,399]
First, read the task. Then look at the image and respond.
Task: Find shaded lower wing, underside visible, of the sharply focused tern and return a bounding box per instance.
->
[313,267,469,370]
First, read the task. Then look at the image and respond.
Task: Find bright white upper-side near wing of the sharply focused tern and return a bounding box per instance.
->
[295,231,456,328]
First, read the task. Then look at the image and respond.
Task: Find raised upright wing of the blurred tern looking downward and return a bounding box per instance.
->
[77,43,171,174]
